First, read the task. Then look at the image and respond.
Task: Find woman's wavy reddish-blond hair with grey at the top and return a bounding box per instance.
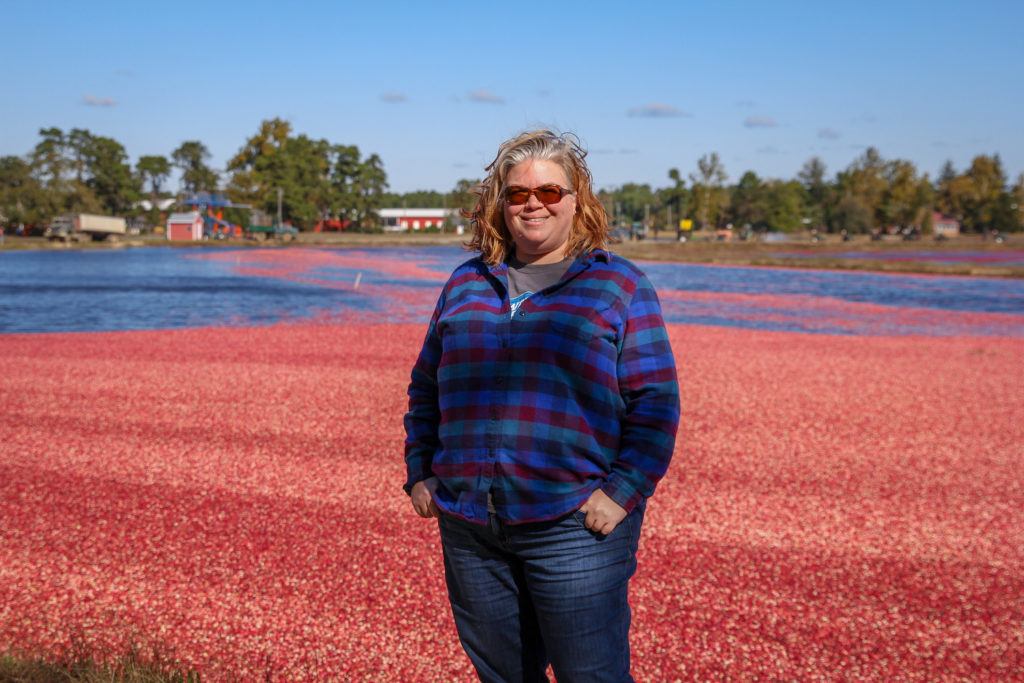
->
[463,129,608,265]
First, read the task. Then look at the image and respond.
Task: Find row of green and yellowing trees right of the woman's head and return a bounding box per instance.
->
[600,147,1024,233]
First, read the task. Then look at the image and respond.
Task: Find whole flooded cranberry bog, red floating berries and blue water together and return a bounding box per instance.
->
[0,249,1024,681]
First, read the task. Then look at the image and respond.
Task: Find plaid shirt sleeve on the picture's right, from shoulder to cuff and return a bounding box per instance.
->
[601,274,679,512]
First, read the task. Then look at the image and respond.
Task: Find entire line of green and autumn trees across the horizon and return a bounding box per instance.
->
[0,119,1024,233]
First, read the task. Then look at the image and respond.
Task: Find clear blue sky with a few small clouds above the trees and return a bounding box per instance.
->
[0,0,1024,191]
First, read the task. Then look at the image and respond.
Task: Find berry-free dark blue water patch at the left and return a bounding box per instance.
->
[0,247,359,332]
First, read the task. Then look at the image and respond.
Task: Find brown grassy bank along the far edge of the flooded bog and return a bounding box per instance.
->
[0,232,1024,278]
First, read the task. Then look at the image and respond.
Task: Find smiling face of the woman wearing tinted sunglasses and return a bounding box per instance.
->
[503,159,577,263]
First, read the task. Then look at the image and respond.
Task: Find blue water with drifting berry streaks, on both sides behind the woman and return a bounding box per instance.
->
[0,247,1024,336]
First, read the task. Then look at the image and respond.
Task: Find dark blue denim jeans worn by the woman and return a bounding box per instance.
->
[440,504,645,683]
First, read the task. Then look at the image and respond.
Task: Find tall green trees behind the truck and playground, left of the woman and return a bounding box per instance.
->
[0,119,388,228]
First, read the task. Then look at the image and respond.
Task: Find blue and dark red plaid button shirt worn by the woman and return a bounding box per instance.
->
[406,250,679,523]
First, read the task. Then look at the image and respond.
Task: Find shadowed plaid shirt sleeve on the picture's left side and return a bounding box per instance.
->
[402,290,446,494]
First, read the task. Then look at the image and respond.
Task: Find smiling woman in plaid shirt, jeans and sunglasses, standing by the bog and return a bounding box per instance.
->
[404,130,679,683]
